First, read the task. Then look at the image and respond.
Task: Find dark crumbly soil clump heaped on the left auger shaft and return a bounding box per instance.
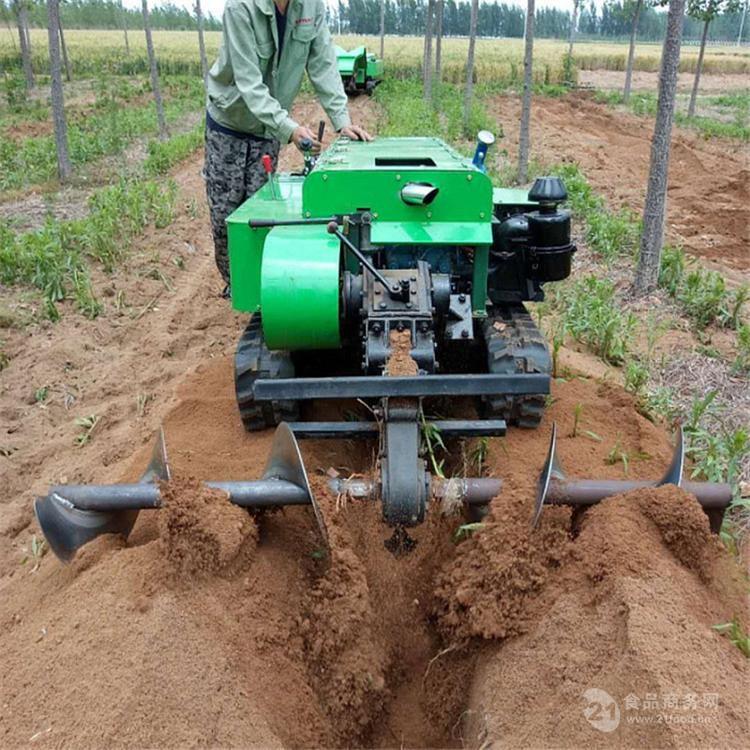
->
[159,479,258,576]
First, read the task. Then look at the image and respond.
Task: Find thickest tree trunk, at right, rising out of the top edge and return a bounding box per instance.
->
[635,0,685,295]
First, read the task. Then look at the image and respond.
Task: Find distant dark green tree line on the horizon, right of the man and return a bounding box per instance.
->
[338,0,750,42]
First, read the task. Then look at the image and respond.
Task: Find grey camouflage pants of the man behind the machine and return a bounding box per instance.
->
[205,128,279,284]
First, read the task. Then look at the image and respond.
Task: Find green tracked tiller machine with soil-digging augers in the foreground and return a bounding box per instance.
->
[36,131,731,559]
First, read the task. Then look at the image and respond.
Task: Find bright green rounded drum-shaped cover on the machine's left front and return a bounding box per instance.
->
[260,226,341,351]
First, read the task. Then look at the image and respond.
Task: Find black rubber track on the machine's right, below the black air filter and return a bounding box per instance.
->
[482,305,552,429]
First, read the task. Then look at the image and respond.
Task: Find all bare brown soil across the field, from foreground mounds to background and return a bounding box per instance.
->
[0,32,750,748]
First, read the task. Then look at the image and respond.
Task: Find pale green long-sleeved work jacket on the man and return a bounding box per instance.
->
[206,0,351,144]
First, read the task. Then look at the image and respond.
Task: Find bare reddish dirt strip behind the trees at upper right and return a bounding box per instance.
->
[490,94,750,279]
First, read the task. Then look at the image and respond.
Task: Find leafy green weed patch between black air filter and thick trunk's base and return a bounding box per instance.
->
[562,276,636,365]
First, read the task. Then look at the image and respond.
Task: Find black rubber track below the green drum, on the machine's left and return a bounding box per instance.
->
[234,313,299,432]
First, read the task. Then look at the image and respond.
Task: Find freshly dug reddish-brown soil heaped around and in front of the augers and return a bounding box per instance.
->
[0,359,747,747]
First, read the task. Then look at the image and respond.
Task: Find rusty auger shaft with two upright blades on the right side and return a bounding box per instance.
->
[532,425,732,534]
